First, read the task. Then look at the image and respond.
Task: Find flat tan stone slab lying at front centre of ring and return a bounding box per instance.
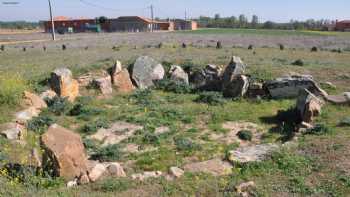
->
[184,158,232,176]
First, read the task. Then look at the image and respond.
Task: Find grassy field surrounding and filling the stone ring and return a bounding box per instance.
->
[0,29,350,196]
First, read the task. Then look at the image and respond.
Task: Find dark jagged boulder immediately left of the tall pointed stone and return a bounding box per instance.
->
[190,64,222,91]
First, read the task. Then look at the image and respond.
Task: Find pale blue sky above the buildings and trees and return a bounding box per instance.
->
[0,0,350,22]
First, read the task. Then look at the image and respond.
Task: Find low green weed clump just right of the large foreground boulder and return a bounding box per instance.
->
[91,144,123,162]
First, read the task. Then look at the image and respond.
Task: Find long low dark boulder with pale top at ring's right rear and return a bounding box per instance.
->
[265,75,328,99]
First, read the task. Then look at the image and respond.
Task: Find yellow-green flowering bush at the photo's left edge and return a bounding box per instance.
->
[0,75,27,105]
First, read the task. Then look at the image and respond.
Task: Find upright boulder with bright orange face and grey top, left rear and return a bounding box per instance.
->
[50,68,79,101]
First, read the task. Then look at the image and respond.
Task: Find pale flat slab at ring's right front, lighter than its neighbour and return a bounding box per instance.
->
[228,144,279,163]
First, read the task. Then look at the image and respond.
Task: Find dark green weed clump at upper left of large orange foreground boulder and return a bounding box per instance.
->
[27,113,55,134]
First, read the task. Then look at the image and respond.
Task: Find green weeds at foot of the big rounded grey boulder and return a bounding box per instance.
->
[156,79,193,94]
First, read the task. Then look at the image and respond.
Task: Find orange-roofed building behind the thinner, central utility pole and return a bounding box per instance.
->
[110,16,174,32]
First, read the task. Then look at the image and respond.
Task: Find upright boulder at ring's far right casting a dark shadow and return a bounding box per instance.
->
[296,89,324,123]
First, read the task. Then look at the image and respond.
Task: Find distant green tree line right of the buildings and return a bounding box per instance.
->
[196,14,334,30]
